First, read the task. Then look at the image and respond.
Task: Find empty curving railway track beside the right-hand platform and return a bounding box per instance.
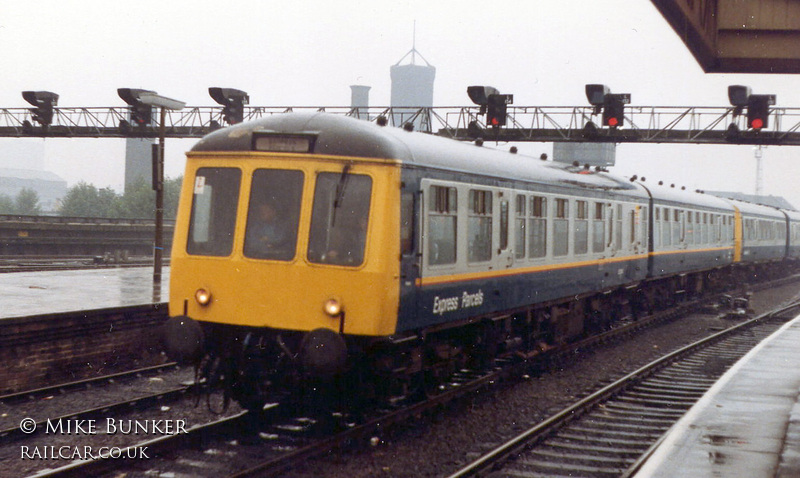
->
[450,301,800,478]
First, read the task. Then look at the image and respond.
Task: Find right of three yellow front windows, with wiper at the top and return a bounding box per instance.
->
[308,172,372,266]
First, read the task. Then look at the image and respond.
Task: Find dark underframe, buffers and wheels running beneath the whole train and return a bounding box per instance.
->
[183,261,800,409]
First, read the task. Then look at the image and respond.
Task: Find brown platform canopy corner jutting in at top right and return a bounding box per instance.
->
[651,0,800,73]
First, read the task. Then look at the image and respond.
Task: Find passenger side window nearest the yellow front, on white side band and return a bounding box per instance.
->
[427,186,458,266]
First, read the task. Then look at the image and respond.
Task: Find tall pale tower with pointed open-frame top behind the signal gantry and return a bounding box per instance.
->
[389,48,436,131]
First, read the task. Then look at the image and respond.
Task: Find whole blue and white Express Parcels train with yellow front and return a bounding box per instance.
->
[165,113,800,408]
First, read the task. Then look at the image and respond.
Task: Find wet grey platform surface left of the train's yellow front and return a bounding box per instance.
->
[0,266,169,320]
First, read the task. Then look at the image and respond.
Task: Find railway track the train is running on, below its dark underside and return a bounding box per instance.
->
[25,292,752,478]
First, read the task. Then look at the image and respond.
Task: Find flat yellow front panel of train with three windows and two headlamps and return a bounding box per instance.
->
[169,152,400,336]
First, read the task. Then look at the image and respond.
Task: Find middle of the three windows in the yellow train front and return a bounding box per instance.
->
[244,169,304,261]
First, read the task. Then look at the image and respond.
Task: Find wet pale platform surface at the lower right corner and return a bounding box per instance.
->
[634,316,800,478]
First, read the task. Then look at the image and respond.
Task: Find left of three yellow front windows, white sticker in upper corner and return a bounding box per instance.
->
[186,168,242,257]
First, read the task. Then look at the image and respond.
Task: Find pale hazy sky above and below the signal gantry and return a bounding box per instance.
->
[0,0,800,207]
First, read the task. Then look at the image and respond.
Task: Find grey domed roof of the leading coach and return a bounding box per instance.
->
[192,113,647,197]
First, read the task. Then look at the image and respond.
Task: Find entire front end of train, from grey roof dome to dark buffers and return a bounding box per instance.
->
[162,114,410,408]
